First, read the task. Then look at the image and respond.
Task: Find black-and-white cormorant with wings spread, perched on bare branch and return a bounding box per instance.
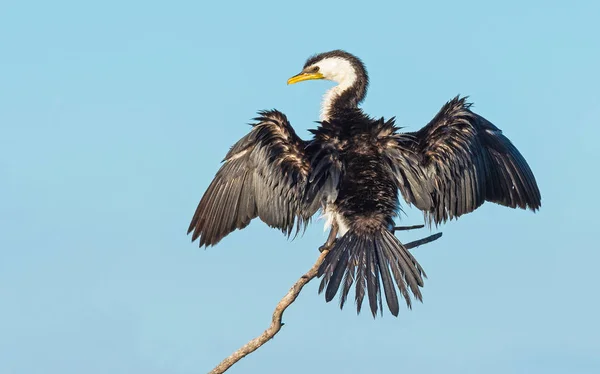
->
[188,49,541,318]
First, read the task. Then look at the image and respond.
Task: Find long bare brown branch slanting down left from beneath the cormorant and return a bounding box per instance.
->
[210,249,329,374]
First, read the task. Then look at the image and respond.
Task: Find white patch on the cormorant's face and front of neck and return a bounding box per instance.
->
[316,57,358,121]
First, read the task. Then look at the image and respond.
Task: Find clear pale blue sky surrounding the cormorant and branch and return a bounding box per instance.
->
[0,0,600,374]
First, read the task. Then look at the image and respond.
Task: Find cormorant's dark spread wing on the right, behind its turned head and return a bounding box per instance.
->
[378,97,541,224]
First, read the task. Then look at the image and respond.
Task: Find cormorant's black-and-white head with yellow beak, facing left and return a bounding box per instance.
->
[287,50,369,91]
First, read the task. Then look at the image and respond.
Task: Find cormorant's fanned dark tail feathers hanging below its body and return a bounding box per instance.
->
[317,227,427,317]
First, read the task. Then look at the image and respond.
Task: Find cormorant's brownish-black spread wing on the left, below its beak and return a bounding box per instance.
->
[188,110,310,246]
